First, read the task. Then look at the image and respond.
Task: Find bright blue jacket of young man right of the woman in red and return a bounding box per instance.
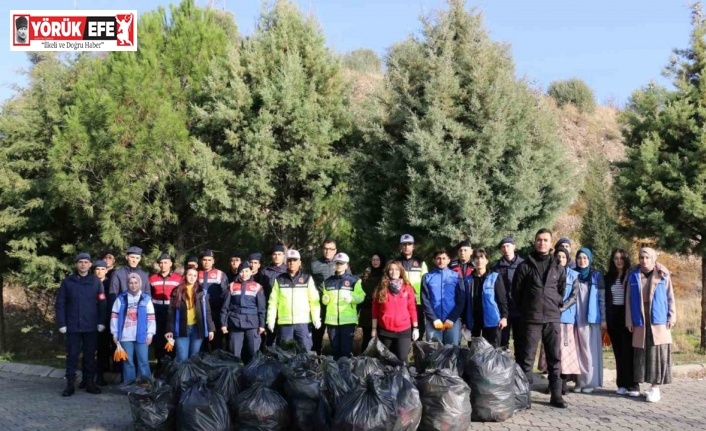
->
[421,268,466,322]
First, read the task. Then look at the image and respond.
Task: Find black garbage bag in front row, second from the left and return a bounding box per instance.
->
[177,378,231,431]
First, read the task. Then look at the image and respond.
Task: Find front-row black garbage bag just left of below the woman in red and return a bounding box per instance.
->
[332,374,397,431]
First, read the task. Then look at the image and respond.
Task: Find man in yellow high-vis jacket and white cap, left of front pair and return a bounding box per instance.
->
[267,250,321,350]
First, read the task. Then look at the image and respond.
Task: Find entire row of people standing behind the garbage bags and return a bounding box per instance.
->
[56,229,676,407]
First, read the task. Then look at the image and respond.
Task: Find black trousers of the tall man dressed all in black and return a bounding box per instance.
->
[515,322,561,394]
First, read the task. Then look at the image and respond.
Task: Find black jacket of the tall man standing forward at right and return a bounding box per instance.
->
[512,253,566,323]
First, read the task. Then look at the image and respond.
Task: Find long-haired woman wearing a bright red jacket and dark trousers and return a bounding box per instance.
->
[371,261,419,363]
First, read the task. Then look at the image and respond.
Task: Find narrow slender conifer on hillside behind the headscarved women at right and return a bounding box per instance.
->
[579,155,627,274]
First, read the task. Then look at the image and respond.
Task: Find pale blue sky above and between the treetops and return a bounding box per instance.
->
[0,0,691,105]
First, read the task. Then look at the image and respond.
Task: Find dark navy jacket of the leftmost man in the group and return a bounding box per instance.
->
[54,273,106,332]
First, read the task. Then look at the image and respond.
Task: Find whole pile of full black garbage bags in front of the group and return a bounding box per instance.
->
[121,338,530,431]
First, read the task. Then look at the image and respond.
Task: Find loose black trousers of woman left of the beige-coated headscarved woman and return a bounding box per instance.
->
[607,305,640,391]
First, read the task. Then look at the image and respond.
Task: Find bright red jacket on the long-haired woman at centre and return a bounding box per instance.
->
[373,284,417,332]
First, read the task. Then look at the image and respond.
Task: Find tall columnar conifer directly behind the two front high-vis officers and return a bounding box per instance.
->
[233,0,350,248]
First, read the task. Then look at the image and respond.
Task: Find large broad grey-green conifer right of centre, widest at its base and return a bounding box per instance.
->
[356,0,571,255]
